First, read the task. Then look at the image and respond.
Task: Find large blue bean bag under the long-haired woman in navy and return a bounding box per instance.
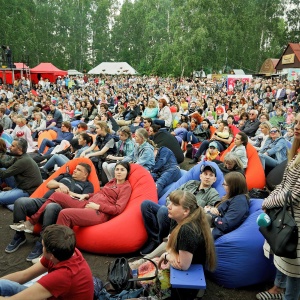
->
[209,199,276,288]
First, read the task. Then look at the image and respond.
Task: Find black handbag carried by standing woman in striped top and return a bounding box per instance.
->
[259,191,298,258]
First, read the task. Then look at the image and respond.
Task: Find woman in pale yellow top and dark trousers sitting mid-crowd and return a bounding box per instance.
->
[189,121,233,164]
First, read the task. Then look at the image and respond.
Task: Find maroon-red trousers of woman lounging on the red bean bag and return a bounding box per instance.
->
[30,192,109,228]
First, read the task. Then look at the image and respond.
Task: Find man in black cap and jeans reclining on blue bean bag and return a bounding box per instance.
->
[140,165,220,255]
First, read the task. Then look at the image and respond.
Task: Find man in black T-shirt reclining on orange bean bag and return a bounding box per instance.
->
[5,163,94,261]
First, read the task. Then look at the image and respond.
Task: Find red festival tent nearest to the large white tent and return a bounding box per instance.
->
[30,63,68,83]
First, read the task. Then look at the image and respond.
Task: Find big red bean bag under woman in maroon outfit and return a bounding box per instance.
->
[73,164,157,254]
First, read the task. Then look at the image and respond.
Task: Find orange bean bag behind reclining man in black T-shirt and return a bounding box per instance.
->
[30,157,100,234]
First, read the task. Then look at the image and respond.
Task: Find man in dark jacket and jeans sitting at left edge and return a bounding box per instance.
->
[0,138,43,209]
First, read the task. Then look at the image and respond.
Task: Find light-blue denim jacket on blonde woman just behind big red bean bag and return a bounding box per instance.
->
[123,142,155,171]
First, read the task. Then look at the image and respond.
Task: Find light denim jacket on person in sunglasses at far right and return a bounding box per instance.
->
[259,136,287,163]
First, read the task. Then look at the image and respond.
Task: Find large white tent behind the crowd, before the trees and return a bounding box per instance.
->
[88,62,137,75]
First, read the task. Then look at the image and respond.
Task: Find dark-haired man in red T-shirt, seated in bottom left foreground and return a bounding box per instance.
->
[0,224,94,300]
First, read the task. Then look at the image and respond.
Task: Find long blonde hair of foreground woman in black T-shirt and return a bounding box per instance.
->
[166,190,216,271]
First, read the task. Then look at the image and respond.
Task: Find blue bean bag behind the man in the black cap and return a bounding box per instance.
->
[158,161,225,205]
